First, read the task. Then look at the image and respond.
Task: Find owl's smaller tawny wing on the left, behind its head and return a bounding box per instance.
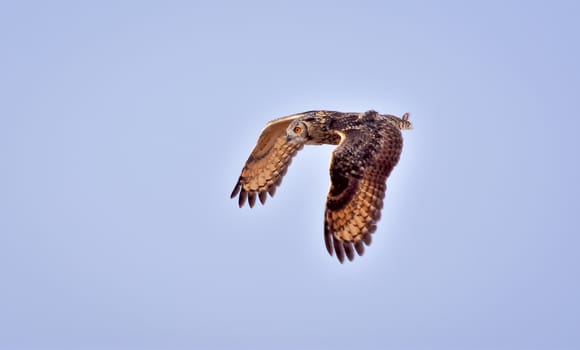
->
[231,114,302,208]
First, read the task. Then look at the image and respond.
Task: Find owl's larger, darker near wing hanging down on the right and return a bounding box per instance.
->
[324,123,403,263]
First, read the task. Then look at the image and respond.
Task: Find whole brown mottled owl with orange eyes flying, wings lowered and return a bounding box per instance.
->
[231,110,413,263]
